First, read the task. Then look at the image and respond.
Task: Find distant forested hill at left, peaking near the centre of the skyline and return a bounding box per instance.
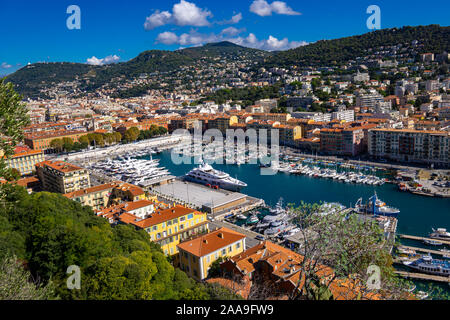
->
[7,41,271,97]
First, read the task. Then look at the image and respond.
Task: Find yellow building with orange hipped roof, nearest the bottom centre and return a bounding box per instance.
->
[178,228,245,280]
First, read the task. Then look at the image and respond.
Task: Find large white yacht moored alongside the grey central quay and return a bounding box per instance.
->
[185,160,247,191]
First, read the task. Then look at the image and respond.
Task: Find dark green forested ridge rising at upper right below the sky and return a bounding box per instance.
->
[266,25,450,67]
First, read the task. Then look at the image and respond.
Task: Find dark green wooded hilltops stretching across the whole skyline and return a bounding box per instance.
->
[7,25,450,98]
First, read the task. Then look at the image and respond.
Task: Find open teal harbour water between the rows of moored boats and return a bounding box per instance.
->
[154,152,450,236]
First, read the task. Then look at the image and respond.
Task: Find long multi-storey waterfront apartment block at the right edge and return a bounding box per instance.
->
[369,129,450,166]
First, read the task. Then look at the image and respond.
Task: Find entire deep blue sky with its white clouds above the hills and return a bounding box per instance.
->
[0,0,450,75]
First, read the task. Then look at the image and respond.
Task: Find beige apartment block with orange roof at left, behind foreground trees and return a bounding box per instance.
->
[36,160,91,193]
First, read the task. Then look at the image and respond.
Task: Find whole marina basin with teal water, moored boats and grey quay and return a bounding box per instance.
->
[72,149,450,292]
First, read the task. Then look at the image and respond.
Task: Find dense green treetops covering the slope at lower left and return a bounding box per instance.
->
[0,185,241,300]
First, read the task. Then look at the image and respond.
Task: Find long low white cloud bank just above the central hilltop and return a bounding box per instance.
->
[156,27,308,51]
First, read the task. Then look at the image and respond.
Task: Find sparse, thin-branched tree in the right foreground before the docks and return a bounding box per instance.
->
[290,203,406,299]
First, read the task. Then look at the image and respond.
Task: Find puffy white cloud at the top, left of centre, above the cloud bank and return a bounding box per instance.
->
[144,0,212,30]
